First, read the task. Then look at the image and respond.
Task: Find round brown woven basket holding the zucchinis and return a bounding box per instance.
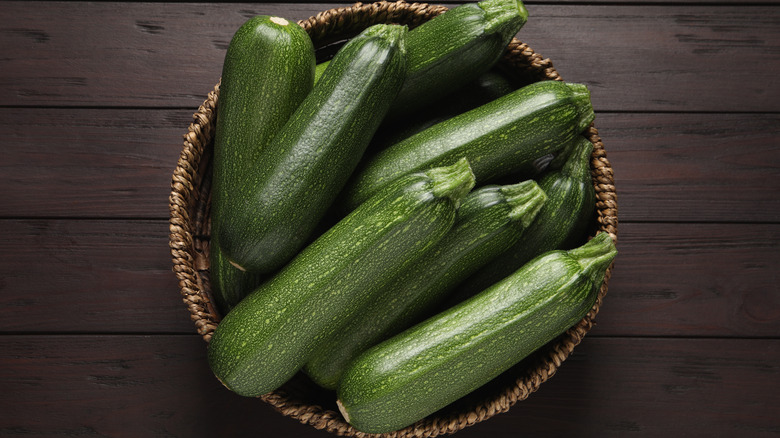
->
[170,2,618,438]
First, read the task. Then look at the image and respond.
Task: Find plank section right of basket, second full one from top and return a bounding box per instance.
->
[596,114,780,222]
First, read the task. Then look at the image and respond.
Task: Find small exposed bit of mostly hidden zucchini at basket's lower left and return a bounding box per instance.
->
[209,235,263,315]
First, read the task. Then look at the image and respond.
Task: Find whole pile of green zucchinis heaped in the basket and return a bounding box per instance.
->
[208,0,616,433]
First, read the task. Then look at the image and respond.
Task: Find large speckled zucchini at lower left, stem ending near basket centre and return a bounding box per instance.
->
[208,160,474,396]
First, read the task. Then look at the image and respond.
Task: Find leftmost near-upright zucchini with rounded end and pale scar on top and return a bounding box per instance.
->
[211,15,316,274]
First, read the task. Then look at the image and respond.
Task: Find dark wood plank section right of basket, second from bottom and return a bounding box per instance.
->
[592,223,780,337]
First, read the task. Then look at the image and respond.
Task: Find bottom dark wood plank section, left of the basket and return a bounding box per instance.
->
[0,336,332,437]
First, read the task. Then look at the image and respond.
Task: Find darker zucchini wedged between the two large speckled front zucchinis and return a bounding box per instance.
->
[304,180,545,389]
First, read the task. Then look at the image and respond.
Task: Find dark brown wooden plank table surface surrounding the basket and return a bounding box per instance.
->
[0,0,780,438]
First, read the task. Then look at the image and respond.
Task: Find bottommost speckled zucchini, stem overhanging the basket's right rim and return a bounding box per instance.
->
[338,233,617,433]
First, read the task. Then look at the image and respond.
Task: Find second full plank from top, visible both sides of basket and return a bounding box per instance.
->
[0,108,780,222]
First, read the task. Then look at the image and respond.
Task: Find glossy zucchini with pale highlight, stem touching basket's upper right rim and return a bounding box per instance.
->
[342,81,594,214]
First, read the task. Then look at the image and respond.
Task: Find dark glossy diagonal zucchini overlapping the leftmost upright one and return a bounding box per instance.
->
[219,24,407,273]
